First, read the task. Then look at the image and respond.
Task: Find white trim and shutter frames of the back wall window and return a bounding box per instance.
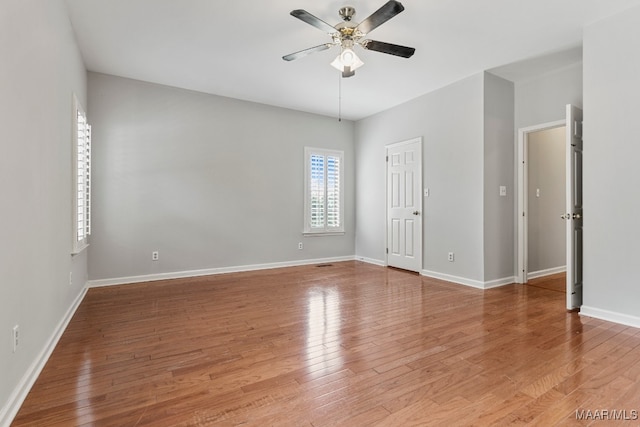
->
[302,147,345,236]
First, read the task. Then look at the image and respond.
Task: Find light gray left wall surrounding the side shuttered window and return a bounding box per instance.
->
[0,0,87,425]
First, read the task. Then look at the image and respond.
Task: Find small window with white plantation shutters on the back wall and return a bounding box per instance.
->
[304,147,344,234]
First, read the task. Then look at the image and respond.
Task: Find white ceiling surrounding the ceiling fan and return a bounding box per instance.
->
[66,0,640,120]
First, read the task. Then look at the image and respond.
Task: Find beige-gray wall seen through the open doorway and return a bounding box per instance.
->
[527,126,567,274]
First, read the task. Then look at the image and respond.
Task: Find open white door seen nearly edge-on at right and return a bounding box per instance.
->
[564,105,583,310]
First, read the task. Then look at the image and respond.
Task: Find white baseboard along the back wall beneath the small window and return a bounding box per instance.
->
[88,256,356,288]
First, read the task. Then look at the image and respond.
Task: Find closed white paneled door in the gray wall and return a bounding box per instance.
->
[387,138,422,272]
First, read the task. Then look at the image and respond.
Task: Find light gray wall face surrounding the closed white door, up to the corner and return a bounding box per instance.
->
[356,73,484,281]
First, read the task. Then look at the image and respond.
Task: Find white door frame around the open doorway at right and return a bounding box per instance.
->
[516,118,567,283]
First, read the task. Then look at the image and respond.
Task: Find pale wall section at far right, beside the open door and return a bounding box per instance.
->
[582,3,640,327]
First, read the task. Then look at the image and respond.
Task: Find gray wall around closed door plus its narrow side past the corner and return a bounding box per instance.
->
[356,73,515,286]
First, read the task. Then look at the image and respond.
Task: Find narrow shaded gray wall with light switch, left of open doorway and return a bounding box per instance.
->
[484,73,517,282]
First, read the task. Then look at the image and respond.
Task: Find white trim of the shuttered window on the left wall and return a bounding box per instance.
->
[71,94,91,255]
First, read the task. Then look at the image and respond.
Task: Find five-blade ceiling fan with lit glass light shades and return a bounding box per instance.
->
[282,0,416,77]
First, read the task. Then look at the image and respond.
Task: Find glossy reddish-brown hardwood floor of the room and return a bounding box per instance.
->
[13,262,640,427]
